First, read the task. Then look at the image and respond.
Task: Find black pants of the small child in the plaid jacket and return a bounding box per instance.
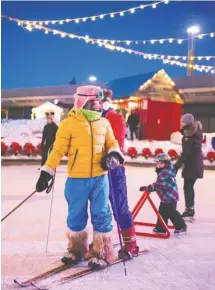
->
[156,202,186,232]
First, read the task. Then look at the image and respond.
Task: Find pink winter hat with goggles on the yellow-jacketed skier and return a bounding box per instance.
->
[74,86,103,109]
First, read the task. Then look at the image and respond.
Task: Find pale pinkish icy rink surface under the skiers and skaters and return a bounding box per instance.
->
[2,165,215,290]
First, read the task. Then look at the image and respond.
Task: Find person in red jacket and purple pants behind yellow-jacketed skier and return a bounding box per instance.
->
[102,90,139,258]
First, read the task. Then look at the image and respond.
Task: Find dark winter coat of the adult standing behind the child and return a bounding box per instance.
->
[175,121,204,179]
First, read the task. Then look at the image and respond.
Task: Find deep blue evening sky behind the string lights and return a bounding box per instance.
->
[2,1,215,89]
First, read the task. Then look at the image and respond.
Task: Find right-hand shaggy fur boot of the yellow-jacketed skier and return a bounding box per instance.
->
[88,232,114,270]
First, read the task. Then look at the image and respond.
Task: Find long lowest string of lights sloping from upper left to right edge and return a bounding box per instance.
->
[2,17,215,72]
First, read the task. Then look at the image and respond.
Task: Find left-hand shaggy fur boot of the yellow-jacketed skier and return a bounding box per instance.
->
[61,231,88,265]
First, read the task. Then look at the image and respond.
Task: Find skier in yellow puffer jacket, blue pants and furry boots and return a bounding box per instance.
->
[36,86,124,268]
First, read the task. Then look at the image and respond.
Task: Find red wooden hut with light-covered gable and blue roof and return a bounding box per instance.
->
[106,69,184,140]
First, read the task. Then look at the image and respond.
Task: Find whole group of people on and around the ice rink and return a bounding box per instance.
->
[36,86,203,269]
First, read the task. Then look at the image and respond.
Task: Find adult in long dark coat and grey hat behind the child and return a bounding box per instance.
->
[175,114,204,218]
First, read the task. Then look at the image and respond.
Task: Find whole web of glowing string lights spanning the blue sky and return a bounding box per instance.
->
[2,0,215,73]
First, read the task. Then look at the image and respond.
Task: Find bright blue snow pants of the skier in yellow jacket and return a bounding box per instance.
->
[65,175,113,233]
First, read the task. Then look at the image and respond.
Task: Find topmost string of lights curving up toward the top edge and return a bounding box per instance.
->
[10,0,169,25]
